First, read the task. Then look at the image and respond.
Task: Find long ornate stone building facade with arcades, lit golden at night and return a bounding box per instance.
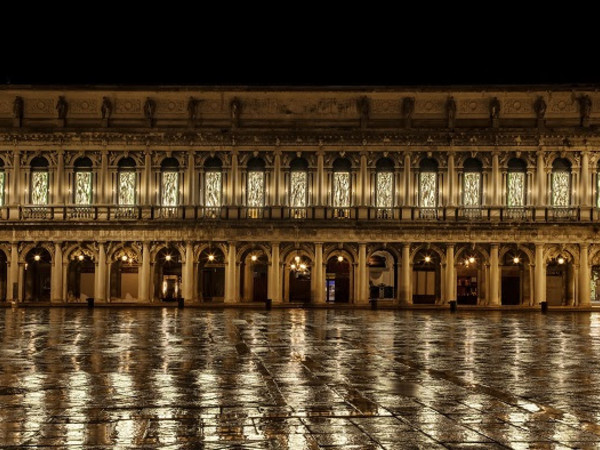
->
[0,87,600,306]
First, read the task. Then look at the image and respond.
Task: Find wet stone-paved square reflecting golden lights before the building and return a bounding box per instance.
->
[0,308,600,449]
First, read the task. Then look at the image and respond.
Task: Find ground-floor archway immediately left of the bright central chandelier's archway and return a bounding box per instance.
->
[240,248,269,302]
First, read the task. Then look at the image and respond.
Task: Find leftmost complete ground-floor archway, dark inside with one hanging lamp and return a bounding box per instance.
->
[23,247,52,302]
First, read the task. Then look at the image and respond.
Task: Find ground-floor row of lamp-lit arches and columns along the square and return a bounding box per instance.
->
[0,241,600,306]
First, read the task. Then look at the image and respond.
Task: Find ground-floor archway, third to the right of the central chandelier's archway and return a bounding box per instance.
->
[412,248,442,305]
